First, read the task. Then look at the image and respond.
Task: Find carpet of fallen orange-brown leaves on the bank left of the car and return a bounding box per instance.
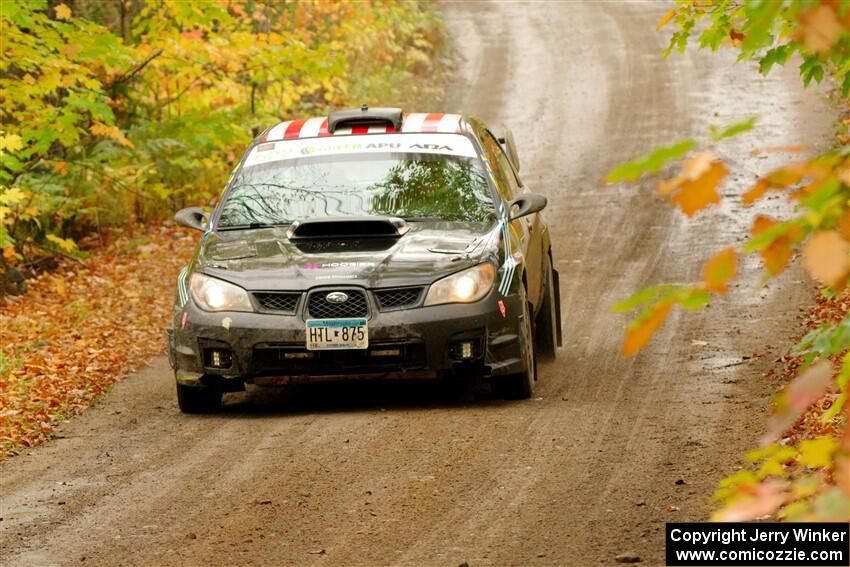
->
[0,227,197,457]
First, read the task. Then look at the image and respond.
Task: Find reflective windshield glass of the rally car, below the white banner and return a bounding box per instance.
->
[218,152,495,228]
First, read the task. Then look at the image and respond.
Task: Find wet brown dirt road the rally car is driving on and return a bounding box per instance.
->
[0,2,832,566]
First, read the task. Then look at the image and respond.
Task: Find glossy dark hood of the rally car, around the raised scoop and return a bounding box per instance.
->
[195,222,498,291]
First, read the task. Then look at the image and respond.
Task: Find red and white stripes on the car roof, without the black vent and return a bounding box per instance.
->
[262,112,460,142]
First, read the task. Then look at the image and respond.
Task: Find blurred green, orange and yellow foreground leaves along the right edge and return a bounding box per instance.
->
[606,0,850,521]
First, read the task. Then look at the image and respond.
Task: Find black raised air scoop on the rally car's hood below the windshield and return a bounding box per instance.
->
[286,217,410,241]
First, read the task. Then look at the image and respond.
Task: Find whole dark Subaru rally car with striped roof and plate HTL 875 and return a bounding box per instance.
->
[168,105,561,413]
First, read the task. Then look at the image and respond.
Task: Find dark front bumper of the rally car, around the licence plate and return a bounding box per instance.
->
[168,289,523,385]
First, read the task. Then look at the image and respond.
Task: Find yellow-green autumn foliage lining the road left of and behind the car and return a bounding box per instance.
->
[0,0,444,259]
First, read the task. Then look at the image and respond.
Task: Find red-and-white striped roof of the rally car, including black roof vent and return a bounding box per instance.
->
[258,111,463,142]
